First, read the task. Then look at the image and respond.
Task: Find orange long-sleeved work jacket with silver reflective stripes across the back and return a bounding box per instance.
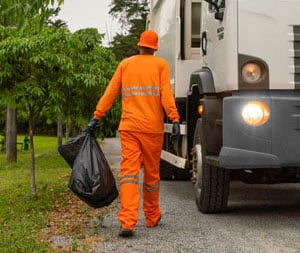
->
[94,55,179,133]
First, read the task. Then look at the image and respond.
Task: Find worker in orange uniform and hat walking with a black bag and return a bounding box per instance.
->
[89,30,180,237]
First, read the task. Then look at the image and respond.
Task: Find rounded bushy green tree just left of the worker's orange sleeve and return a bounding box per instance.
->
[59,28,121,137]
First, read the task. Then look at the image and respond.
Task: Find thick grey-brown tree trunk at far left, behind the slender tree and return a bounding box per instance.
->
[5,106,17,162]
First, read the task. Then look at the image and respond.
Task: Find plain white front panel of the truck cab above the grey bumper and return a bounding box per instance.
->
[238,0,300,89]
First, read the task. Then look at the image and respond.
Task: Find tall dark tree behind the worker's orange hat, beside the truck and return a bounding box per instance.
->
[109,0,149,60]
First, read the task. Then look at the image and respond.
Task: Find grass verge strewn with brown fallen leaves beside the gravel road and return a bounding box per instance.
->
[0,136,113,253]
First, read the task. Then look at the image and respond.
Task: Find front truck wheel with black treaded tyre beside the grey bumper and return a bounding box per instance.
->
[192,144,230,213]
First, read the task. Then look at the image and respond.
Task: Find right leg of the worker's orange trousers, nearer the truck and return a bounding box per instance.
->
[142,134,163,227]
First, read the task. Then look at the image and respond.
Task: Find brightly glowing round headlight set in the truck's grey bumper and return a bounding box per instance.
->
[242,101,270,126]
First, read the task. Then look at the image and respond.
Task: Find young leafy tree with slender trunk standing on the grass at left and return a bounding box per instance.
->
[0,27,71,197]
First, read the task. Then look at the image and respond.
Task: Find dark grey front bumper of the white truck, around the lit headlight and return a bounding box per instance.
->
[219,90,300,169]
